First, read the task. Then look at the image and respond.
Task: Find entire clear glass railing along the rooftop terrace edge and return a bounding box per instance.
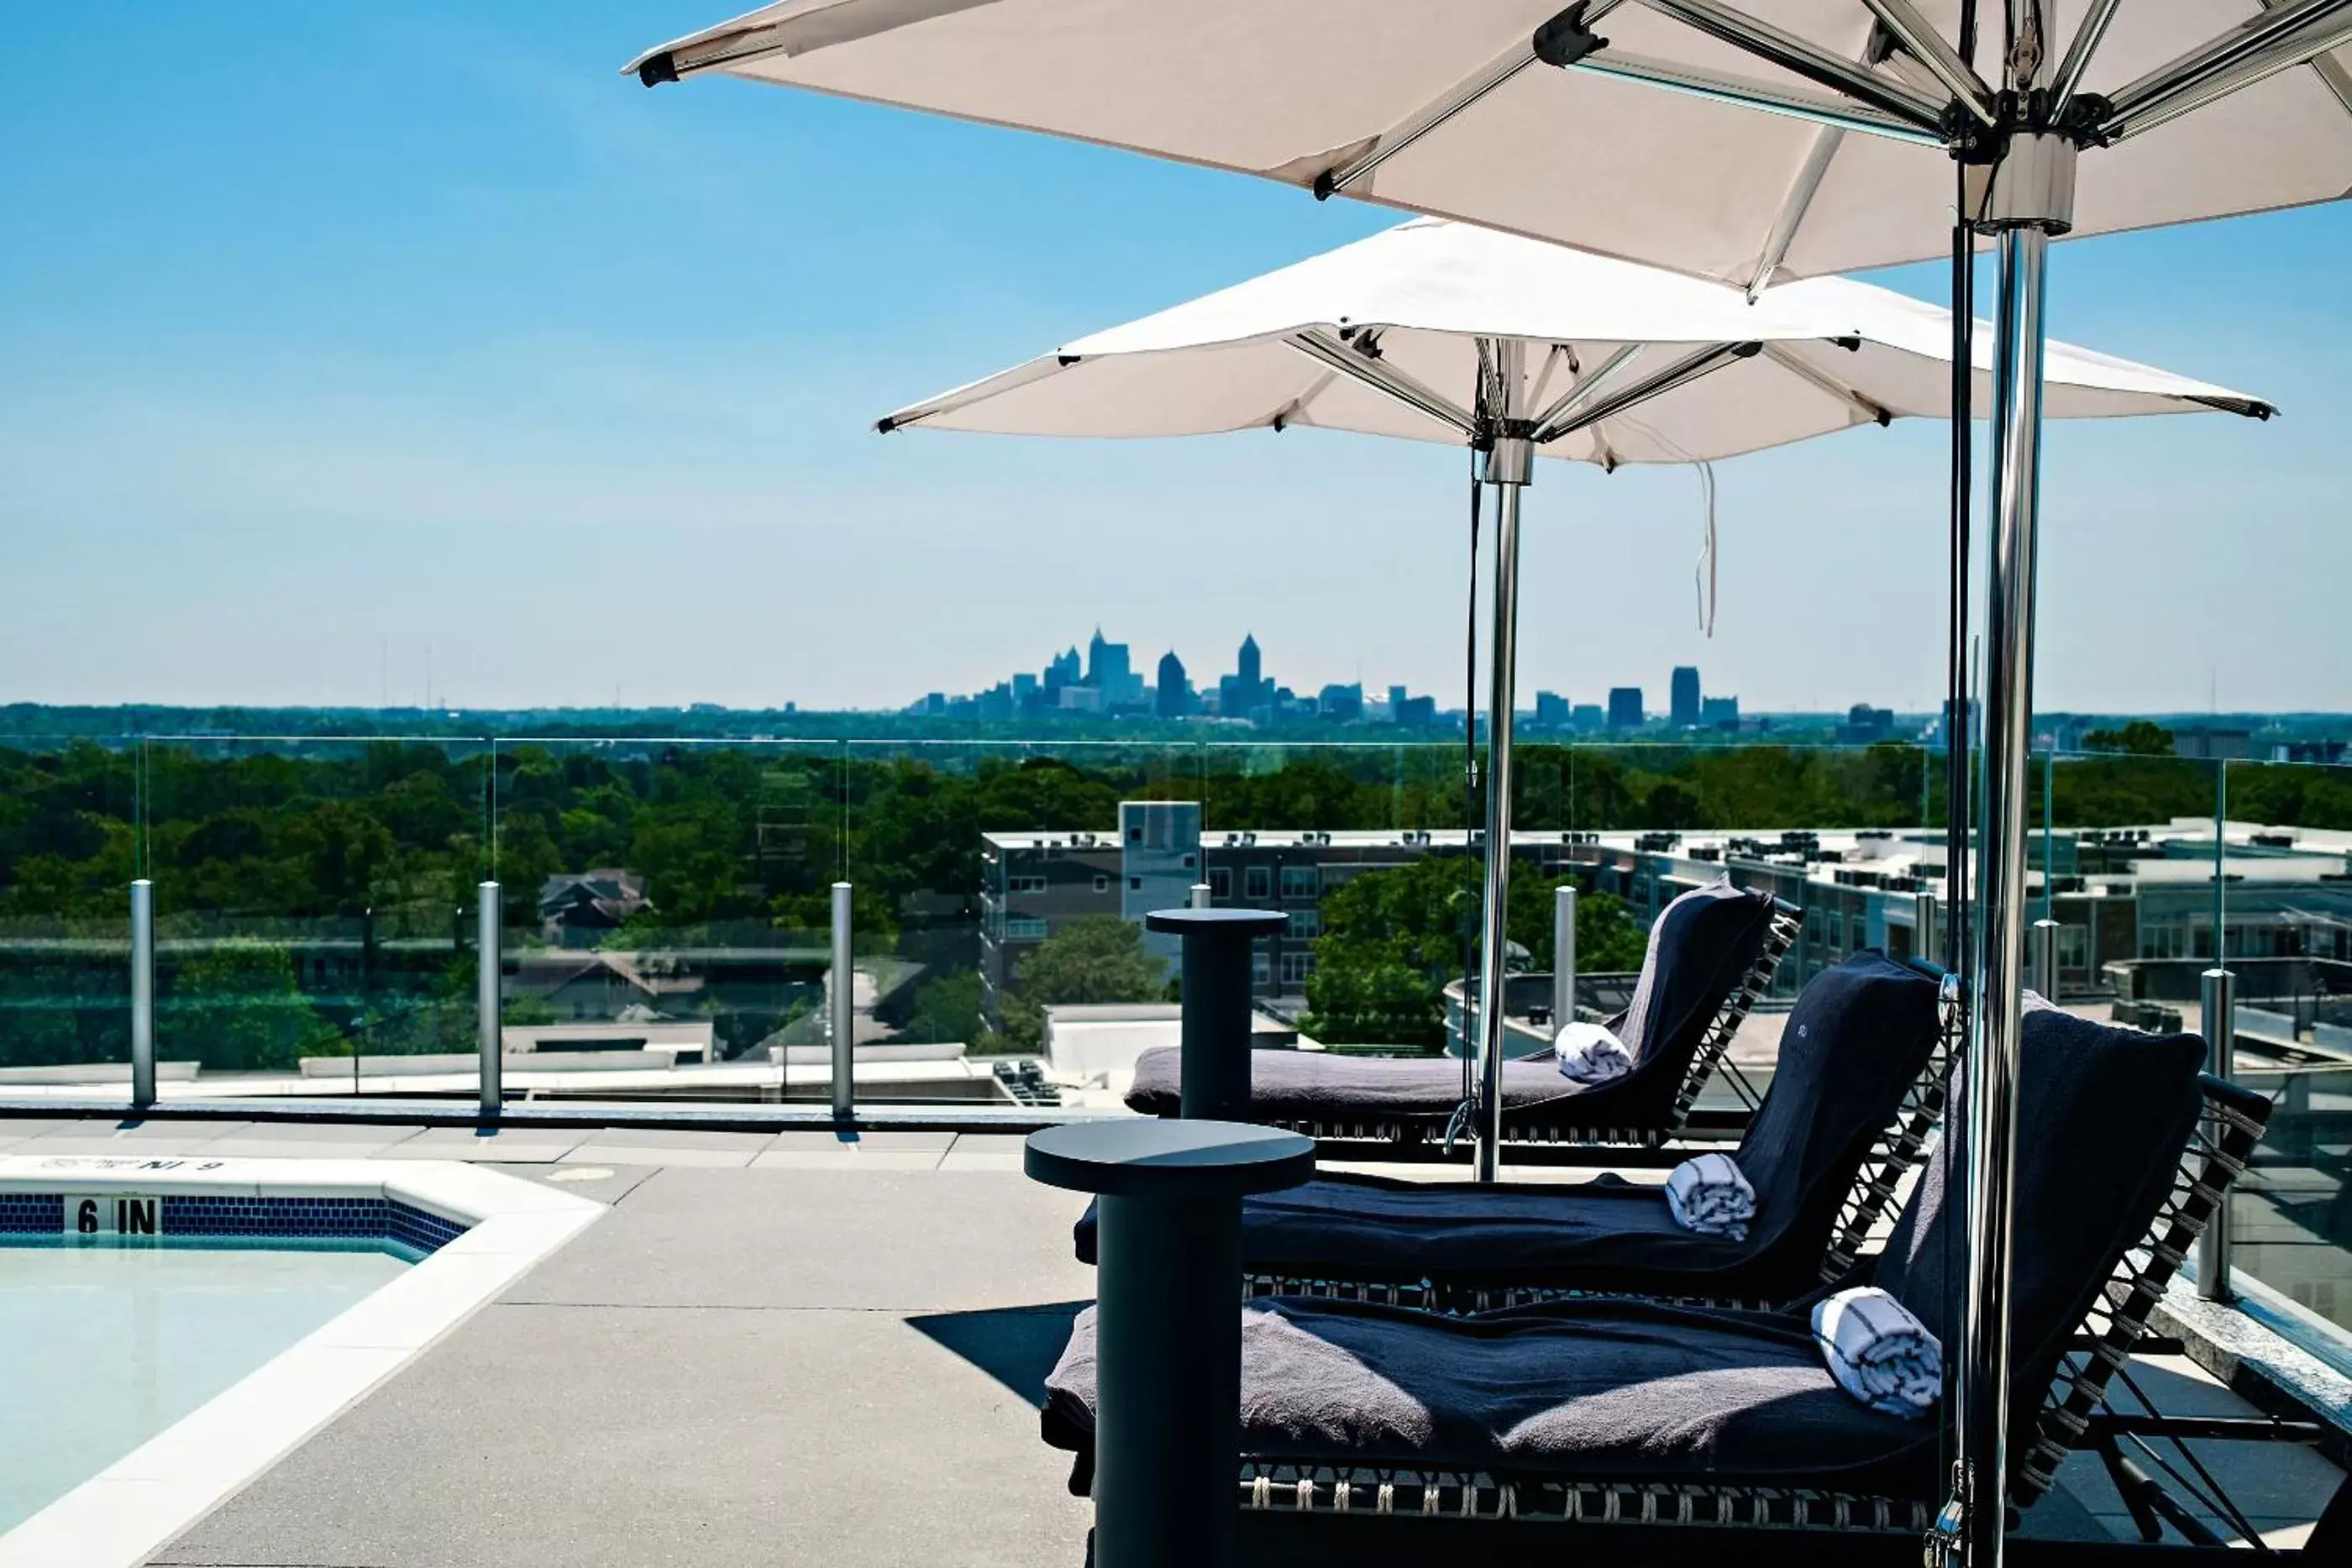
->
[0,736,2352,1363]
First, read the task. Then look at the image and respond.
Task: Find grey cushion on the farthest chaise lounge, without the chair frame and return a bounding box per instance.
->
[1126,877,1773,1130]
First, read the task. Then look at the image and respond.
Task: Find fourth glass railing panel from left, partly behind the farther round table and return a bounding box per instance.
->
[847,741,1206,1109]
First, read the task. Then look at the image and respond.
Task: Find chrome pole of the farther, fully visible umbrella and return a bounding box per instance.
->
[1477,425,1534,1183]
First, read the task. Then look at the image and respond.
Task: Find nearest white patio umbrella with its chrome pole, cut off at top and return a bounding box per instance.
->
[630,0,2352,1568]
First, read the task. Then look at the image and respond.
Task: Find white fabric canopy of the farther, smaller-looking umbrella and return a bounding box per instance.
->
[882,218,2272,468]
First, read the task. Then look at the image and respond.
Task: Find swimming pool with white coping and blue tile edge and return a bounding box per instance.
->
[0,1154,602,1568]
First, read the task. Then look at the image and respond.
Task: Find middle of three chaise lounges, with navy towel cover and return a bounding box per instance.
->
[1075,952,1950,1312]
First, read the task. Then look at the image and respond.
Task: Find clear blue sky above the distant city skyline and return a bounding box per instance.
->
[0,0,2352,710]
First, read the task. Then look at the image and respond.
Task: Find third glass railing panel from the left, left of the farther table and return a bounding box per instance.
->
[494,738,847,1100]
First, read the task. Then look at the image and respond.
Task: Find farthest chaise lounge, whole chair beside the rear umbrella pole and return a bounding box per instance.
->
[1126,877,1799,1145]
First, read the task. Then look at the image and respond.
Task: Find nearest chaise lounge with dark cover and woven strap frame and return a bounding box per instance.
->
[1042,1011,2270,1561]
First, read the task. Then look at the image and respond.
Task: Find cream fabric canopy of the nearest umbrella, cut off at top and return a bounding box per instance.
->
[630,0,2352,286]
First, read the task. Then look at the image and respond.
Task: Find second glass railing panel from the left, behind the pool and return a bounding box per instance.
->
[141,736,489,1095]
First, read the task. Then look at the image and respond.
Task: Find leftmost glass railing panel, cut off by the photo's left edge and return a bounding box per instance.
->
[0,736,144,1098]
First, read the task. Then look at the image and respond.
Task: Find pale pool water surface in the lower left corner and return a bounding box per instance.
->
[0,1244,409,1533]
